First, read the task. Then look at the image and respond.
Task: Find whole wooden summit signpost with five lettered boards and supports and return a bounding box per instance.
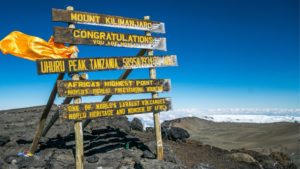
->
[30,7,177,169]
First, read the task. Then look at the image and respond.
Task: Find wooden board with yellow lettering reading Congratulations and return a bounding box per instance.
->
[54,27,167,51]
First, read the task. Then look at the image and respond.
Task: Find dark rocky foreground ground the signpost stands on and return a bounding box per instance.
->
[0,107,297,169]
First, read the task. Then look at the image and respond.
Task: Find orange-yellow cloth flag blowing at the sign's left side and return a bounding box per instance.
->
[0,31,78,61]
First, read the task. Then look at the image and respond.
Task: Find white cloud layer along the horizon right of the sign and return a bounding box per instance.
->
[128,108,300,127]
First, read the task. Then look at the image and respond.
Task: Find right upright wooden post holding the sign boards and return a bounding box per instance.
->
[144,16,164,160]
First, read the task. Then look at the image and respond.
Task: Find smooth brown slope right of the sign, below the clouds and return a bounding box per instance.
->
[165,117,300,168]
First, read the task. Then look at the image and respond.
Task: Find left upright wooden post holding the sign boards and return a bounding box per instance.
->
[67,6,84,169]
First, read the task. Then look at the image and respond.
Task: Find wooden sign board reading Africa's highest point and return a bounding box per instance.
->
[57,79,170,97]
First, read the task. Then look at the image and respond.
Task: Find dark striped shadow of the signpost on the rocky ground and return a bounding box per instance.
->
[35,128,150,156]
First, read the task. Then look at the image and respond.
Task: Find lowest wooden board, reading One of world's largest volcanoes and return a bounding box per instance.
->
[59,98,171,120]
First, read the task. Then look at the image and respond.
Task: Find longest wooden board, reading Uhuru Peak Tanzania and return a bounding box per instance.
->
[36,55,177,74]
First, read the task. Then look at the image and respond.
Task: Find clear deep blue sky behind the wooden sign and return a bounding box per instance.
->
[0,0,300,109]
